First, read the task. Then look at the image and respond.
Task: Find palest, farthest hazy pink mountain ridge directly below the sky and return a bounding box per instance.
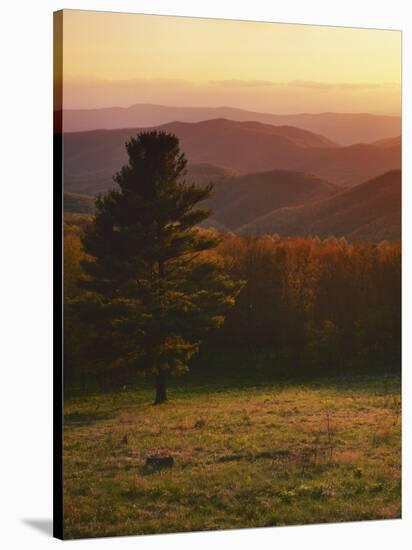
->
[63,104,401,145]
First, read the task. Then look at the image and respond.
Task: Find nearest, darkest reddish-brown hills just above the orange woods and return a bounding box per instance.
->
[64,166,401,241]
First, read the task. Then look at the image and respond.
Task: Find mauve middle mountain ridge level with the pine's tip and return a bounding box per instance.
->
[64,119,401,194]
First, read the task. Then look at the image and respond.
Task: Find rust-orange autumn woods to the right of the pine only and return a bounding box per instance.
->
[214,235,401,370]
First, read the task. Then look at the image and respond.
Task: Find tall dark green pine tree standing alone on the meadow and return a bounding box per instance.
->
[79,131,240,403]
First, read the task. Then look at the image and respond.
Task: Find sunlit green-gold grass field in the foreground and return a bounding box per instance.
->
[64,356,401,538]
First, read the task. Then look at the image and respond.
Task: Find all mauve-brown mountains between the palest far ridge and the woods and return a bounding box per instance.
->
[64,119,401,240]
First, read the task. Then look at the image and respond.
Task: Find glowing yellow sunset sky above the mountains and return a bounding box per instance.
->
[63,10,401,114]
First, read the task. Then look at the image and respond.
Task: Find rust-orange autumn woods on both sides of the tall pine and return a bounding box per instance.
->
[65,216,401,389]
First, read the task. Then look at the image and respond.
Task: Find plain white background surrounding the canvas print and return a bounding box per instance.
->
[0,0,412,550]
